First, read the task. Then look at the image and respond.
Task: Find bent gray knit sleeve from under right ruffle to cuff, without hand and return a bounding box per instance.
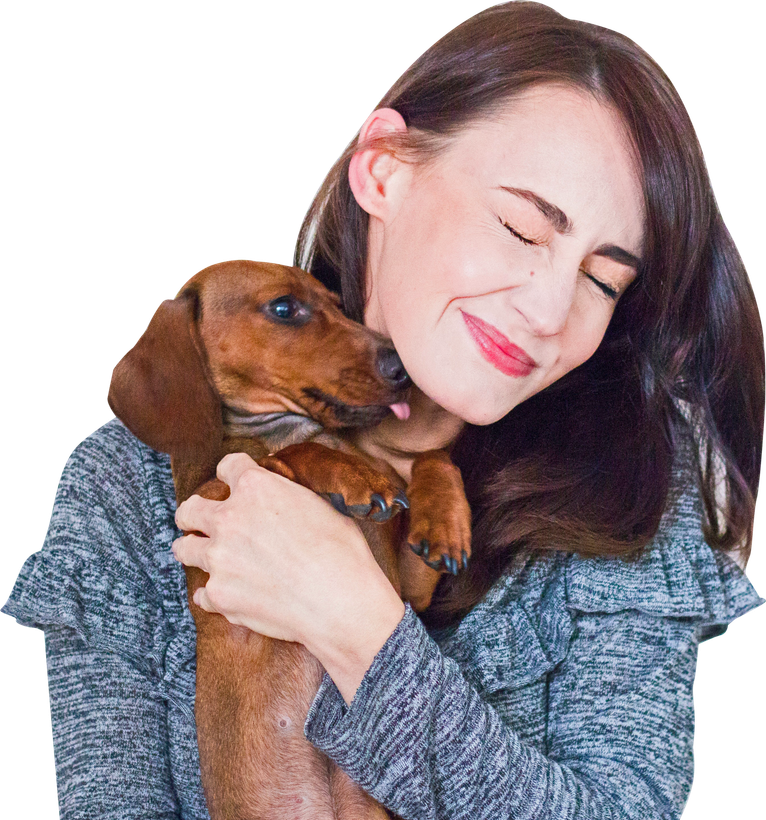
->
[306,607,697,820]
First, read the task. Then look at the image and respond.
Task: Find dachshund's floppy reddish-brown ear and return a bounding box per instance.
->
[106,290,223,462]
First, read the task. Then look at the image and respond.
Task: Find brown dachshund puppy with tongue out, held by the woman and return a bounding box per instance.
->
[107,259,470,820]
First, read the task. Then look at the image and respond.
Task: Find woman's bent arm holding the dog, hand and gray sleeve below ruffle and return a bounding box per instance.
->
[174,448,697,820]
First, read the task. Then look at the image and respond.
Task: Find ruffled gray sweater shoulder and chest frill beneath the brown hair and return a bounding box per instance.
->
[440,436,766,692]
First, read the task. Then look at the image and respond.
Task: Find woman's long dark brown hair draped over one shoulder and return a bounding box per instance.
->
[295,2,766,624]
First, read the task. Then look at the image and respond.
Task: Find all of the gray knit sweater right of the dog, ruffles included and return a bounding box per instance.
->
[305,420,764,820]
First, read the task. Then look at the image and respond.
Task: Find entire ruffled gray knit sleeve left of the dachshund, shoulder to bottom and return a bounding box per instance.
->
[2,420,207,820]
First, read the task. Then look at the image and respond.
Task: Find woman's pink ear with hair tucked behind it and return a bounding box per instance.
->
[348,108,407,219]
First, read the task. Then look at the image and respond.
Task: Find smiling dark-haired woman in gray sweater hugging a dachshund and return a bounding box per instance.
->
[5,3,764,820]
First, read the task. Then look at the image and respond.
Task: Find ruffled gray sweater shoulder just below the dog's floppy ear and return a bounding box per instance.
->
[3,419,188,662]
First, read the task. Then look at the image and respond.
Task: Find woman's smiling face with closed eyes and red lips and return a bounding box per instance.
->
[362,86,644,424]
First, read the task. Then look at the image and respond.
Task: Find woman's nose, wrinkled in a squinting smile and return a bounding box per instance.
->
[513,264,580,336]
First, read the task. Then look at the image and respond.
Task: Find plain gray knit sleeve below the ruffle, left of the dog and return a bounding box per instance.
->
[45,627,181,820]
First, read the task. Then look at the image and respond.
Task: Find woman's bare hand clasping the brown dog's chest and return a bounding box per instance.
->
[173,453,404,703]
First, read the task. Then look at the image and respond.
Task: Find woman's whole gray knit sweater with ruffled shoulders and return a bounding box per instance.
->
[2,419,763,820]
